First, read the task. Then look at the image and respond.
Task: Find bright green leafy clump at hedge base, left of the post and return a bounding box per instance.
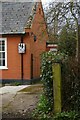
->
[32,94,51,120]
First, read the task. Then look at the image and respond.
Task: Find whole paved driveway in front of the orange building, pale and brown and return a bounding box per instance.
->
[0,85,42,120]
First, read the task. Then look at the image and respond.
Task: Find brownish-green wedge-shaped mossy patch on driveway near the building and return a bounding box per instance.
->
[19,84,43,94]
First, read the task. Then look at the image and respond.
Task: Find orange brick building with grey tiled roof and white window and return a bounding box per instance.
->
[0,2,48,83]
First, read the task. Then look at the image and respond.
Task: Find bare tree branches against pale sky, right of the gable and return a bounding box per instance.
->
[45,0,80,34]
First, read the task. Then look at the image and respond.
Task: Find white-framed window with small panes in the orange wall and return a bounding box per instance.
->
[0,38,7,69]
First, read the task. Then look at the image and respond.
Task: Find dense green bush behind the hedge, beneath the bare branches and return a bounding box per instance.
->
[58,26,76,56]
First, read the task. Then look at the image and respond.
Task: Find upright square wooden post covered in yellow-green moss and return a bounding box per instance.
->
[52,63,61,113]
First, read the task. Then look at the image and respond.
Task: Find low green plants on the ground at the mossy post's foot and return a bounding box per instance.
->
[52,111,79,120]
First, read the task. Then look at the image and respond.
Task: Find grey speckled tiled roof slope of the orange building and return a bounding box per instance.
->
[0,2,37,34]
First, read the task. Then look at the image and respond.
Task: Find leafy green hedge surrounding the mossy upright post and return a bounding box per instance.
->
[33,52,80,120]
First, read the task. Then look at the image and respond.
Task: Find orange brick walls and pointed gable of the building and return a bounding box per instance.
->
[0,4,48,79]
